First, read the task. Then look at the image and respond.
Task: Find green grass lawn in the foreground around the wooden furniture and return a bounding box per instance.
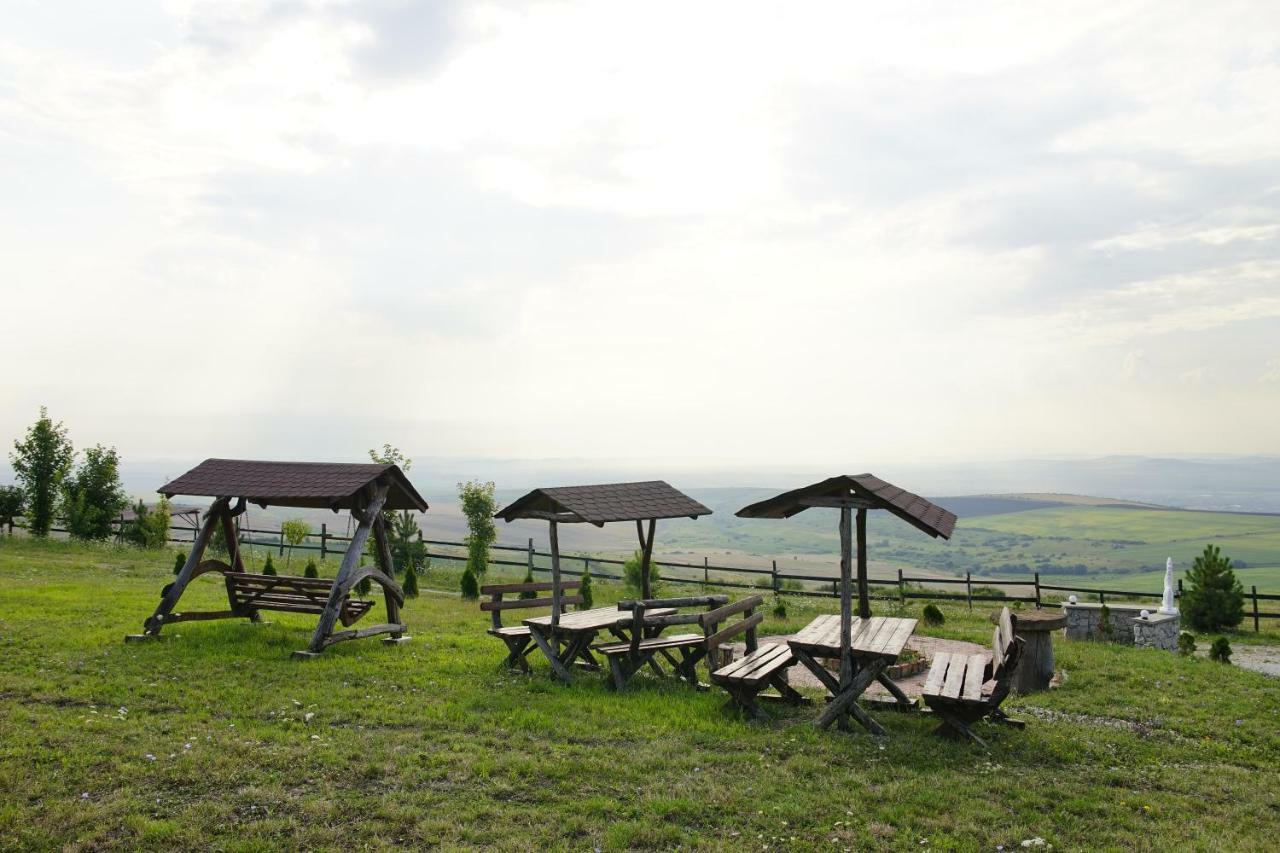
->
[0,538,1280,850]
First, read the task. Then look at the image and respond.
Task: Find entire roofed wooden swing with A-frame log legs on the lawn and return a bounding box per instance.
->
[128,459,428,657]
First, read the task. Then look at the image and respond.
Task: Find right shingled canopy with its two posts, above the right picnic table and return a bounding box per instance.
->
[736,474,956,681]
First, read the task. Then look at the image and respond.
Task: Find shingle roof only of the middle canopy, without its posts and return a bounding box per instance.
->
[494,480,710,526]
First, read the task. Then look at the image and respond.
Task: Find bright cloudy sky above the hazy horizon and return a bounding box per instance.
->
[0,0,1280,466]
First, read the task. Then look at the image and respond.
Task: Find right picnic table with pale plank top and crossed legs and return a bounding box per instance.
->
[787,613,916,734]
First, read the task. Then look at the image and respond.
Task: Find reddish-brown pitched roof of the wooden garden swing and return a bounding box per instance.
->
[157,459,428,512]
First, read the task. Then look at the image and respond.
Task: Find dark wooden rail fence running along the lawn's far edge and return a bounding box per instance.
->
[9,519,1280,631]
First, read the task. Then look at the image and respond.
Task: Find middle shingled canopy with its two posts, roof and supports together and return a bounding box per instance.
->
[494,480,712,614]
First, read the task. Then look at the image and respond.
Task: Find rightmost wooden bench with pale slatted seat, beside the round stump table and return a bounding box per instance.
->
[923,607,1027,747]
